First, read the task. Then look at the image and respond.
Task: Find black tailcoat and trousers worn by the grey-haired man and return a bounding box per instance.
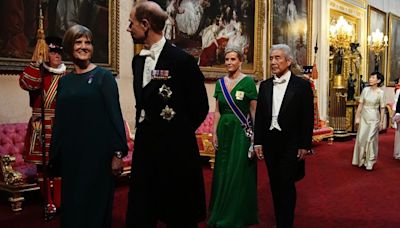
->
[254,74,314,227]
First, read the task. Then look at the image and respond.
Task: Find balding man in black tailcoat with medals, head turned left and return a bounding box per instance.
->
[126,1,209,228]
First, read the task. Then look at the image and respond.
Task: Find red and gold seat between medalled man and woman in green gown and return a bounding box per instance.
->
[196,112,215,168]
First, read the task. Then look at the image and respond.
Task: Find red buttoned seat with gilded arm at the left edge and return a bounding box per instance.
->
[0,123,39,211]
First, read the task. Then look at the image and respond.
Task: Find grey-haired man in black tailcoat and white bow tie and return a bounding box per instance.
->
[254,44,314,228]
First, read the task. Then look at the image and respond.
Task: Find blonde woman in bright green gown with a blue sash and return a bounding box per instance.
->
[208,46,258,228]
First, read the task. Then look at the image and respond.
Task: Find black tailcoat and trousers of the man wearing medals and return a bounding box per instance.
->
[127,42,209,227]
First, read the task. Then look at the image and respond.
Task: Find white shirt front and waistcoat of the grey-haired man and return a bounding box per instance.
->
[269,71,291,131]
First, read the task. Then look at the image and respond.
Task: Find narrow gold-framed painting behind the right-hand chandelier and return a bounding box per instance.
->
[367,5,387,82]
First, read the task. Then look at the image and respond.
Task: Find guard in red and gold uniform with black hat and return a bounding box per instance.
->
[19,37,66,219]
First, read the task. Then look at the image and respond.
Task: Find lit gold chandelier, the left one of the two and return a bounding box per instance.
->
[329,16,353,48]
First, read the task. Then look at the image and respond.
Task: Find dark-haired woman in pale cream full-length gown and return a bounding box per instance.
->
[352,72,386,170]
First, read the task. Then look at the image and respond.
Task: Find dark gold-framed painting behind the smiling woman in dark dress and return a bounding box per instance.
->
[0,0,119,74]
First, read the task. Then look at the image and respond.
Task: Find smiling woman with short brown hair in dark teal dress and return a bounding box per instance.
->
[50,25,128,228]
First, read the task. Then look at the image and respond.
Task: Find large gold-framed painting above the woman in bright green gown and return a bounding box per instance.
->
[134,0,265,80]
